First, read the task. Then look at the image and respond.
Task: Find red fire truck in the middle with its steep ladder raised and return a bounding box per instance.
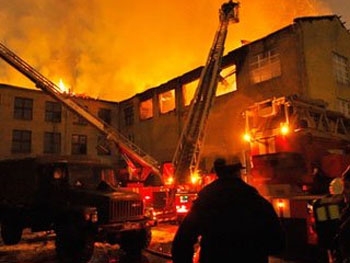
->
[100,0,239,223]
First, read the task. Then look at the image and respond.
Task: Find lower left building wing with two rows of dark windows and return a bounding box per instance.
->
[0,84,117,162]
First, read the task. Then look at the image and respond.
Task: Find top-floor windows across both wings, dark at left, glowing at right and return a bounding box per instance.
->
[8,49,350,137]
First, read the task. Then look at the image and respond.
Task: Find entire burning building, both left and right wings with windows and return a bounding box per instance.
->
[0,16,350,174]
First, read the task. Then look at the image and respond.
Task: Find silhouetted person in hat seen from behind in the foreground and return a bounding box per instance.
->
[172,158,285,263]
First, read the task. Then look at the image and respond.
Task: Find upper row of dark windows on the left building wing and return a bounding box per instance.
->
[13,97,112,125]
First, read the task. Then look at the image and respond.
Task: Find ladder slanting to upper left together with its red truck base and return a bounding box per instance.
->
[0,43,171,222]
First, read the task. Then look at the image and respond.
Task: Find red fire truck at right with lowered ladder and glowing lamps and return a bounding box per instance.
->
[244,95,350,260]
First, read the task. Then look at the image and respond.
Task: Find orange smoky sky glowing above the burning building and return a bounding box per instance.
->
[0,0,350,101]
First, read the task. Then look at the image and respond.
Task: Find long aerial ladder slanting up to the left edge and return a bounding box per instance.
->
[0,43,161,175]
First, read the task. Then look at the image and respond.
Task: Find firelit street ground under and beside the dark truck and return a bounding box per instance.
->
[0,224,312,263]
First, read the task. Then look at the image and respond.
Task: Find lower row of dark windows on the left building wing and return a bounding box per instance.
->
[11,130,110,155]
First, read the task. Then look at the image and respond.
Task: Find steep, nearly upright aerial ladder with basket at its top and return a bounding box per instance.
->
[172,0,239,184]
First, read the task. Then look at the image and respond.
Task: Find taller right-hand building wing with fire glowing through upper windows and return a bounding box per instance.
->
[118,16,350,170]
